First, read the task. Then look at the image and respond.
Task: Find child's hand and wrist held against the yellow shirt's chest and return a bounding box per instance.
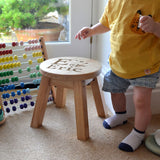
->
[140,16,160,38]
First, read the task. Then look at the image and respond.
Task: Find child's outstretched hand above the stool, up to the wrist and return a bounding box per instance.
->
[75,27,92,40]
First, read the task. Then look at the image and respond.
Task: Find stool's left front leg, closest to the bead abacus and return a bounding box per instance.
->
[31,76,51,128]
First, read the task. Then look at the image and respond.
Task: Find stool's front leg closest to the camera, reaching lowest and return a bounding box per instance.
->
[74,81,89,141]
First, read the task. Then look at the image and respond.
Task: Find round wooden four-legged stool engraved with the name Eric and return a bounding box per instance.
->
[31,57,105,140]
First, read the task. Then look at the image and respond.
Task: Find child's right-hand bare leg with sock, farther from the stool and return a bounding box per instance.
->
[119,87,152,152]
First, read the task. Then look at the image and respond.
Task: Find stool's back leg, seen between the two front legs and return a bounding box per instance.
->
[56,86,66,108]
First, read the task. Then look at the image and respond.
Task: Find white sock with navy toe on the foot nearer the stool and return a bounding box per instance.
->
[103,111,127,129]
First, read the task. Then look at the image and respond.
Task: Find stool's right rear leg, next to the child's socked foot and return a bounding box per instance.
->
[91,77,105,118]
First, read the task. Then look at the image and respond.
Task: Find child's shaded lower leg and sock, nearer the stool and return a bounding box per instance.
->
[103,93,127,129]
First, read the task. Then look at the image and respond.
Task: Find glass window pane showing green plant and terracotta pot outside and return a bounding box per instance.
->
[0,0,70,43]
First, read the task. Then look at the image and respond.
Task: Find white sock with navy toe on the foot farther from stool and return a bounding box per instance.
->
[119,128,145,152]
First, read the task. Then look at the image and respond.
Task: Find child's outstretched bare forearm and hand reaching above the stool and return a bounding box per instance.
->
[75,23,110,40]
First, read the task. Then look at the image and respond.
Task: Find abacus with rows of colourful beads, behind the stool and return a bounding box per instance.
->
[0,38,53,118]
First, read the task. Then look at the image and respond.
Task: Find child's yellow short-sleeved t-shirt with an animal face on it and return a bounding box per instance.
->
[100,0,160,79]
